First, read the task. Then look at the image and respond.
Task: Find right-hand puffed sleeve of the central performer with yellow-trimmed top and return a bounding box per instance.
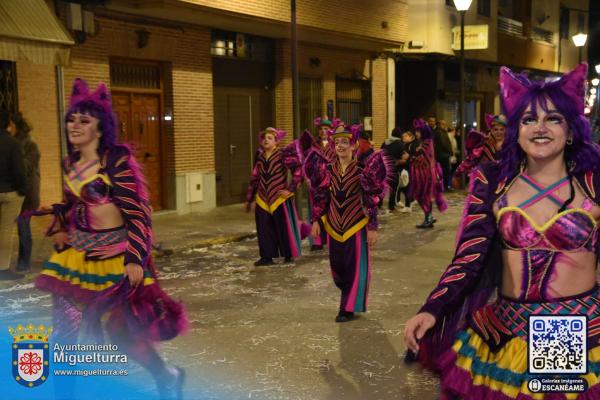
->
[360,150,393,231]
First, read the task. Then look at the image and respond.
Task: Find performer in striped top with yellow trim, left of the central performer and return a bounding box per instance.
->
[245,128,302,267]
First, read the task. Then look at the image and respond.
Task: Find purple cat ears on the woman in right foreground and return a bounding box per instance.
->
[500,63,587,117]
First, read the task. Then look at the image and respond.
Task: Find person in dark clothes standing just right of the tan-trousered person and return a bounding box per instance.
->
[14,112,40,272]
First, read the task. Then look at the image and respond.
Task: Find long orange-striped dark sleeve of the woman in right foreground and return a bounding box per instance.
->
[419,164,498,369]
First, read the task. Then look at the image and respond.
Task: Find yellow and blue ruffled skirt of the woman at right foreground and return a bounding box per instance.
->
[437,288,600,400]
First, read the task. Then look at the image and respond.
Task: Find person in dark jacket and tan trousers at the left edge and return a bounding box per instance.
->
[0,110,25,280]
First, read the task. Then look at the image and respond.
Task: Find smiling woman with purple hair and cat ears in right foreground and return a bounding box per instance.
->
[405,64,600,400]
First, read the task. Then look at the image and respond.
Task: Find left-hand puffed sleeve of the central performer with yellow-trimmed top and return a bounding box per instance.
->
[304,150,330,222]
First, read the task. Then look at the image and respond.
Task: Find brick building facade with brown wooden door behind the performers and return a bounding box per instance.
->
[9,0,407,213]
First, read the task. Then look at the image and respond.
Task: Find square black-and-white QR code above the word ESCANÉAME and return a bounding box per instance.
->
[527,315,587,374]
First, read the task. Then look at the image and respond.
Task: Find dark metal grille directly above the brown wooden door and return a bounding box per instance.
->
[110,62,161,89]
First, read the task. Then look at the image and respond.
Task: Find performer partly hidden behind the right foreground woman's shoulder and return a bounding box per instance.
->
[454,114,507,177]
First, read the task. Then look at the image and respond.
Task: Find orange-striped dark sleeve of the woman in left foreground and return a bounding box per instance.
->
[106,149,152,268]
